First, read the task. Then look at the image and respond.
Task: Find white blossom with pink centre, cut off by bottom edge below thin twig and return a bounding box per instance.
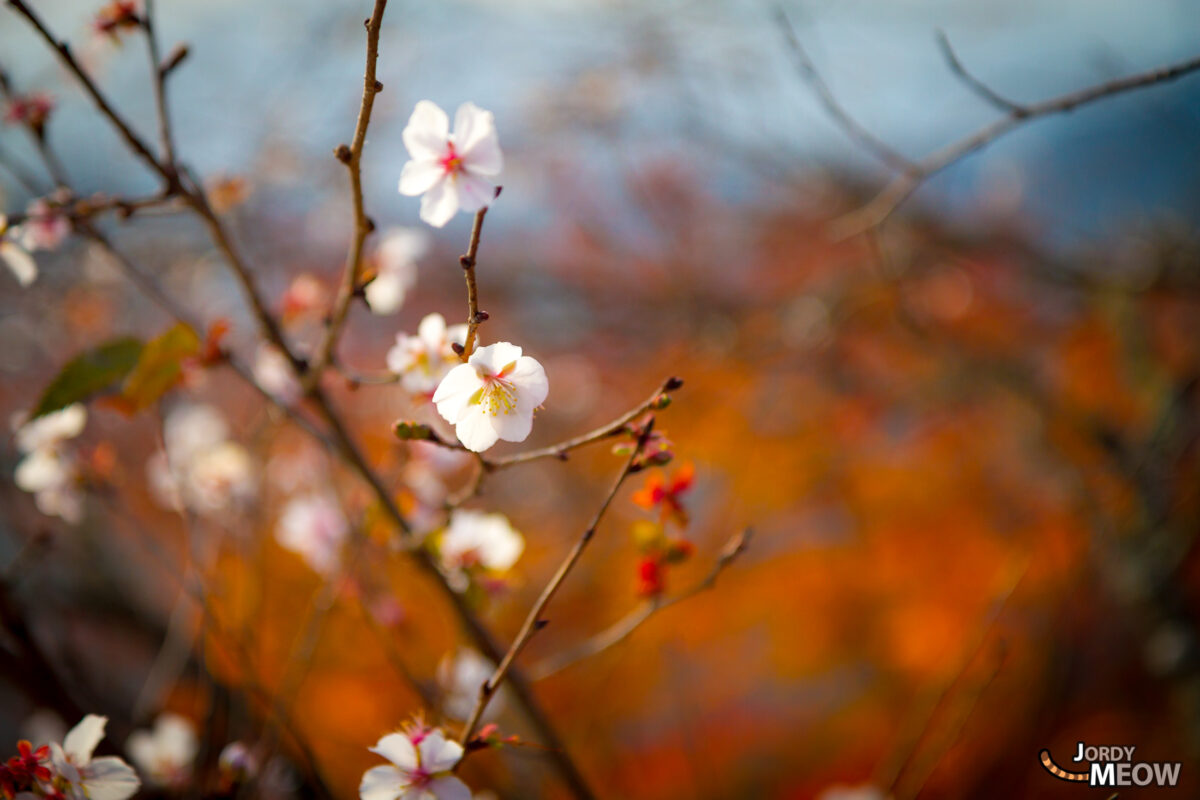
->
[359,728,470,800]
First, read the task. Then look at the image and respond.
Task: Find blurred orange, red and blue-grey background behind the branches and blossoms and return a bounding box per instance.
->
[0,0,1200,798]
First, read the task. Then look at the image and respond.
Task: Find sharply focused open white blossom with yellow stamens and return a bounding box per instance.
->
[433,342,550,452]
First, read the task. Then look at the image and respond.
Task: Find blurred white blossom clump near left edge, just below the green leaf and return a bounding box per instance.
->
[13,403,88,524]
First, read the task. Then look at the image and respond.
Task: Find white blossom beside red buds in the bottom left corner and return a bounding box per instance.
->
[50,714,142,800]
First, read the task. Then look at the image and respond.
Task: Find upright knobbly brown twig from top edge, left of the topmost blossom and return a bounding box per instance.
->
[305,0,388,391]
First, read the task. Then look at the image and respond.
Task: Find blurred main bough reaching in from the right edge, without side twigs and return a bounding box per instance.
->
[833,47,1200,239]
